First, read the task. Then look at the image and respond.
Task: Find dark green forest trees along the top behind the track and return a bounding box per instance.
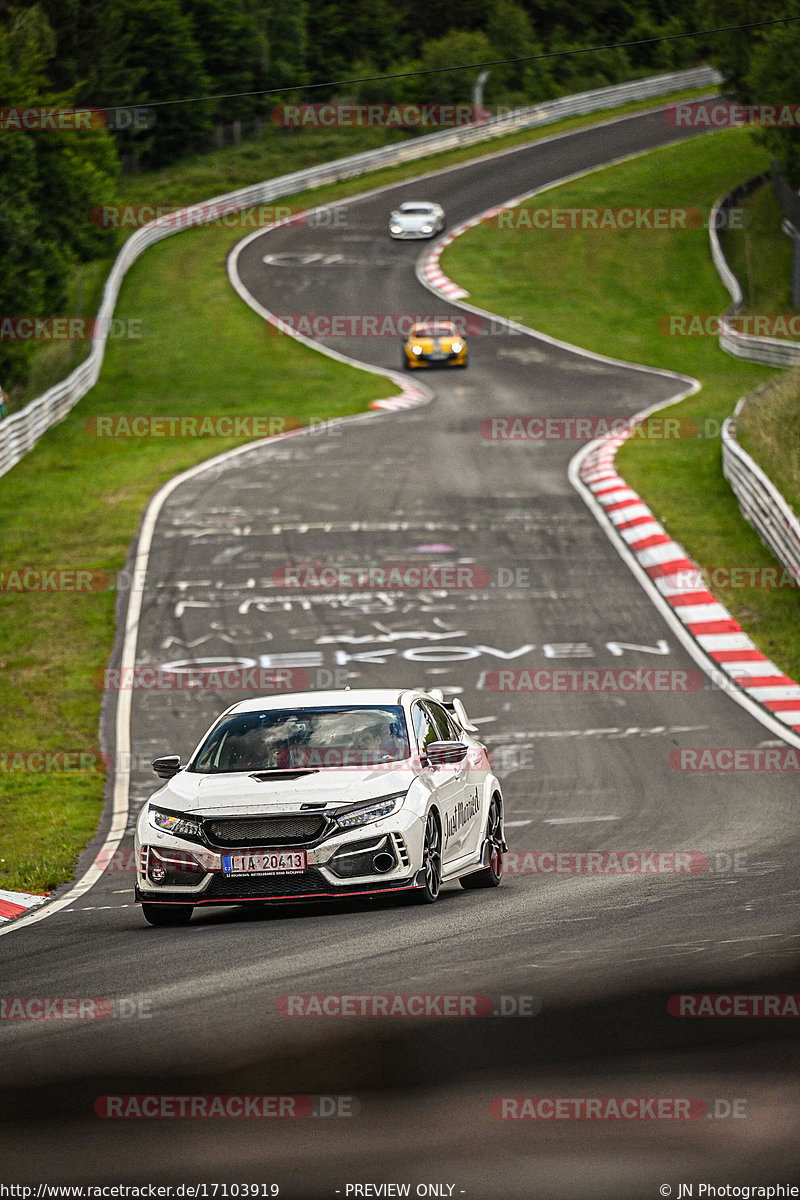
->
[0,0,800,385]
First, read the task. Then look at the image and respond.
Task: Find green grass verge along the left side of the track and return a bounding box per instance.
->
[0,84,714,892]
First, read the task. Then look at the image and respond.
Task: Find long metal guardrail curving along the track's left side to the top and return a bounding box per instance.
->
[0,67,722,475]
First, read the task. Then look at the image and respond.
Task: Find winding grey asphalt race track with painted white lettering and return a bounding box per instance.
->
[0,103,800,1200]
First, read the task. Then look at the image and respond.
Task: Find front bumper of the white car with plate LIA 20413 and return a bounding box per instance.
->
[136,810,423,905]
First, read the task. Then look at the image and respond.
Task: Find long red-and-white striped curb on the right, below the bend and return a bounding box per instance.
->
[579,433,800,733]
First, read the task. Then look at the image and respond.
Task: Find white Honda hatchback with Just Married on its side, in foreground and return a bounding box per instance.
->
[136,689,506,925]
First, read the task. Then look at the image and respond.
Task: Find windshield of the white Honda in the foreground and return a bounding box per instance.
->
[188,704,409,774]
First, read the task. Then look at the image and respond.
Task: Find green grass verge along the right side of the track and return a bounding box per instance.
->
[443,130,800,677]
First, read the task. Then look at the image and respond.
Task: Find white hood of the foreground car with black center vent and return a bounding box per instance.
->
[151,763,416,816]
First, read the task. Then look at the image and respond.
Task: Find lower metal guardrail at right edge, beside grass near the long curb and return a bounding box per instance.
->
[722,384,800,583]
